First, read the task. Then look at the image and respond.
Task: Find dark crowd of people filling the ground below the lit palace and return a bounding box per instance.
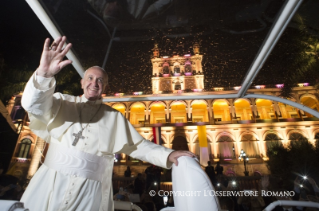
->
[0,162,319,211]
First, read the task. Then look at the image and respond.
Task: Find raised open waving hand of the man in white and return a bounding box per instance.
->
[37,36,72,78]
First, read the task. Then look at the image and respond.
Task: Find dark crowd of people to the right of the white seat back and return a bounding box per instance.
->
[205,161,319,211]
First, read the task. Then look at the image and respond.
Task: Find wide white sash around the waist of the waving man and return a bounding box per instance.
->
[44,142,107,182]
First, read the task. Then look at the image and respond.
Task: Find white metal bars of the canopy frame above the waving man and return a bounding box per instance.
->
[26,0,319,118]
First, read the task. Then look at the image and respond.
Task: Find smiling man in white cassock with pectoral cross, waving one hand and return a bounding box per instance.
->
[21,37,194,211]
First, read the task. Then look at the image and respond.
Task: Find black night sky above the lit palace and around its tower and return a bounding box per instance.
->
[0,0,319,102]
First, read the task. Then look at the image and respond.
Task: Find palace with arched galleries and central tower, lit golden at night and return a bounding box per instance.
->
[4,43,319,178]
